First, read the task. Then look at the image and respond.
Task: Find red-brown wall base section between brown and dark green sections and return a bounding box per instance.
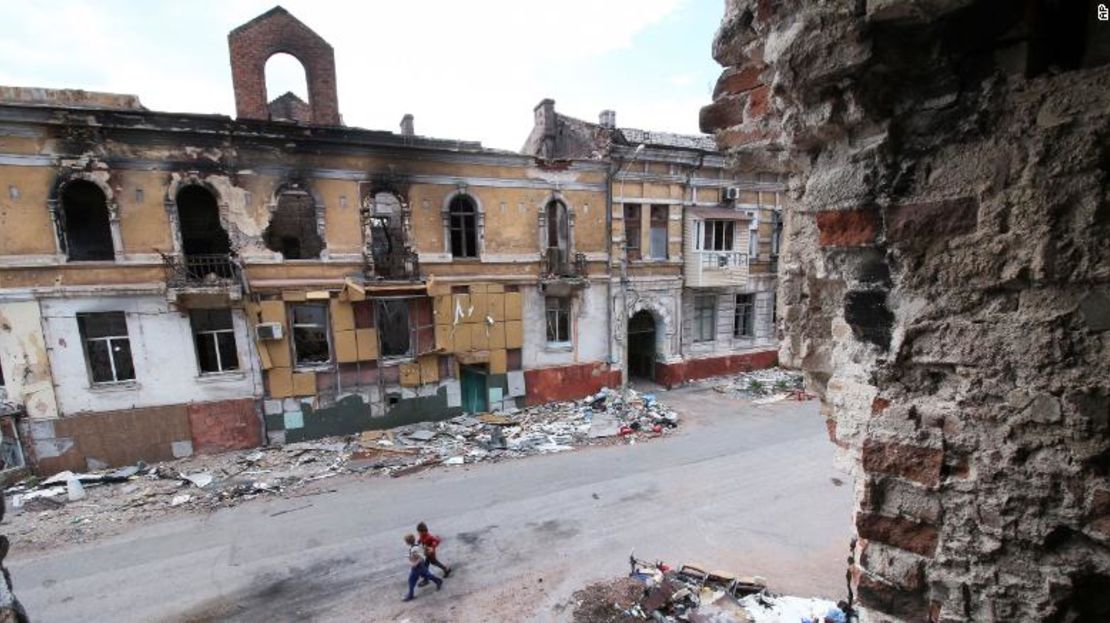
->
[188,398,262,454]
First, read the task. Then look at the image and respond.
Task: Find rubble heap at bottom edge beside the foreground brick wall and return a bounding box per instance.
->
[572,555,837,623]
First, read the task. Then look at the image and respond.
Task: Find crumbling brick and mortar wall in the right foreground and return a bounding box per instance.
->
[702,0,1110,621]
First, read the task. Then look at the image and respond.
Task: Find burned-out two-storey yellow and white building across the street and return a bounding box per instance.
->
[0,8,781,473]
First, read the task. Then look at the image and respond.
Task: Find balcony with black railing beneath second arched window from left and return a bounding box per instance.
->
[162,253,243,308]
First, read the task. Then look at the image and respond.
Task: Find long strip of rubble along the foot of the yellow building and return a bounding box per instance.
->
[4,389,678,549]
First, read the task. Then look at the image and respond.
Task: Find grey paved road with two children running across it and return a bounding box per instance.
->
[9,390,851,623]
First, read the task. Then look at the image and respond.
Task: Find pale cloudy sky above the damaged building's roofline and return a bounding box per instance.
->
[0,0,724,150]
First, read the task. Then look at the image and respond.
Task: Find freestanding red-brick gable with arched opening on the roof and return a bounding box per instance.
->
[228,7,341,125]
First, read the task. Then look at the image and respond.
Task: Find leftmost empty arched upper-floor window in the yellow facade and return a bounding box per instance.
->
[61,180,115,262]
